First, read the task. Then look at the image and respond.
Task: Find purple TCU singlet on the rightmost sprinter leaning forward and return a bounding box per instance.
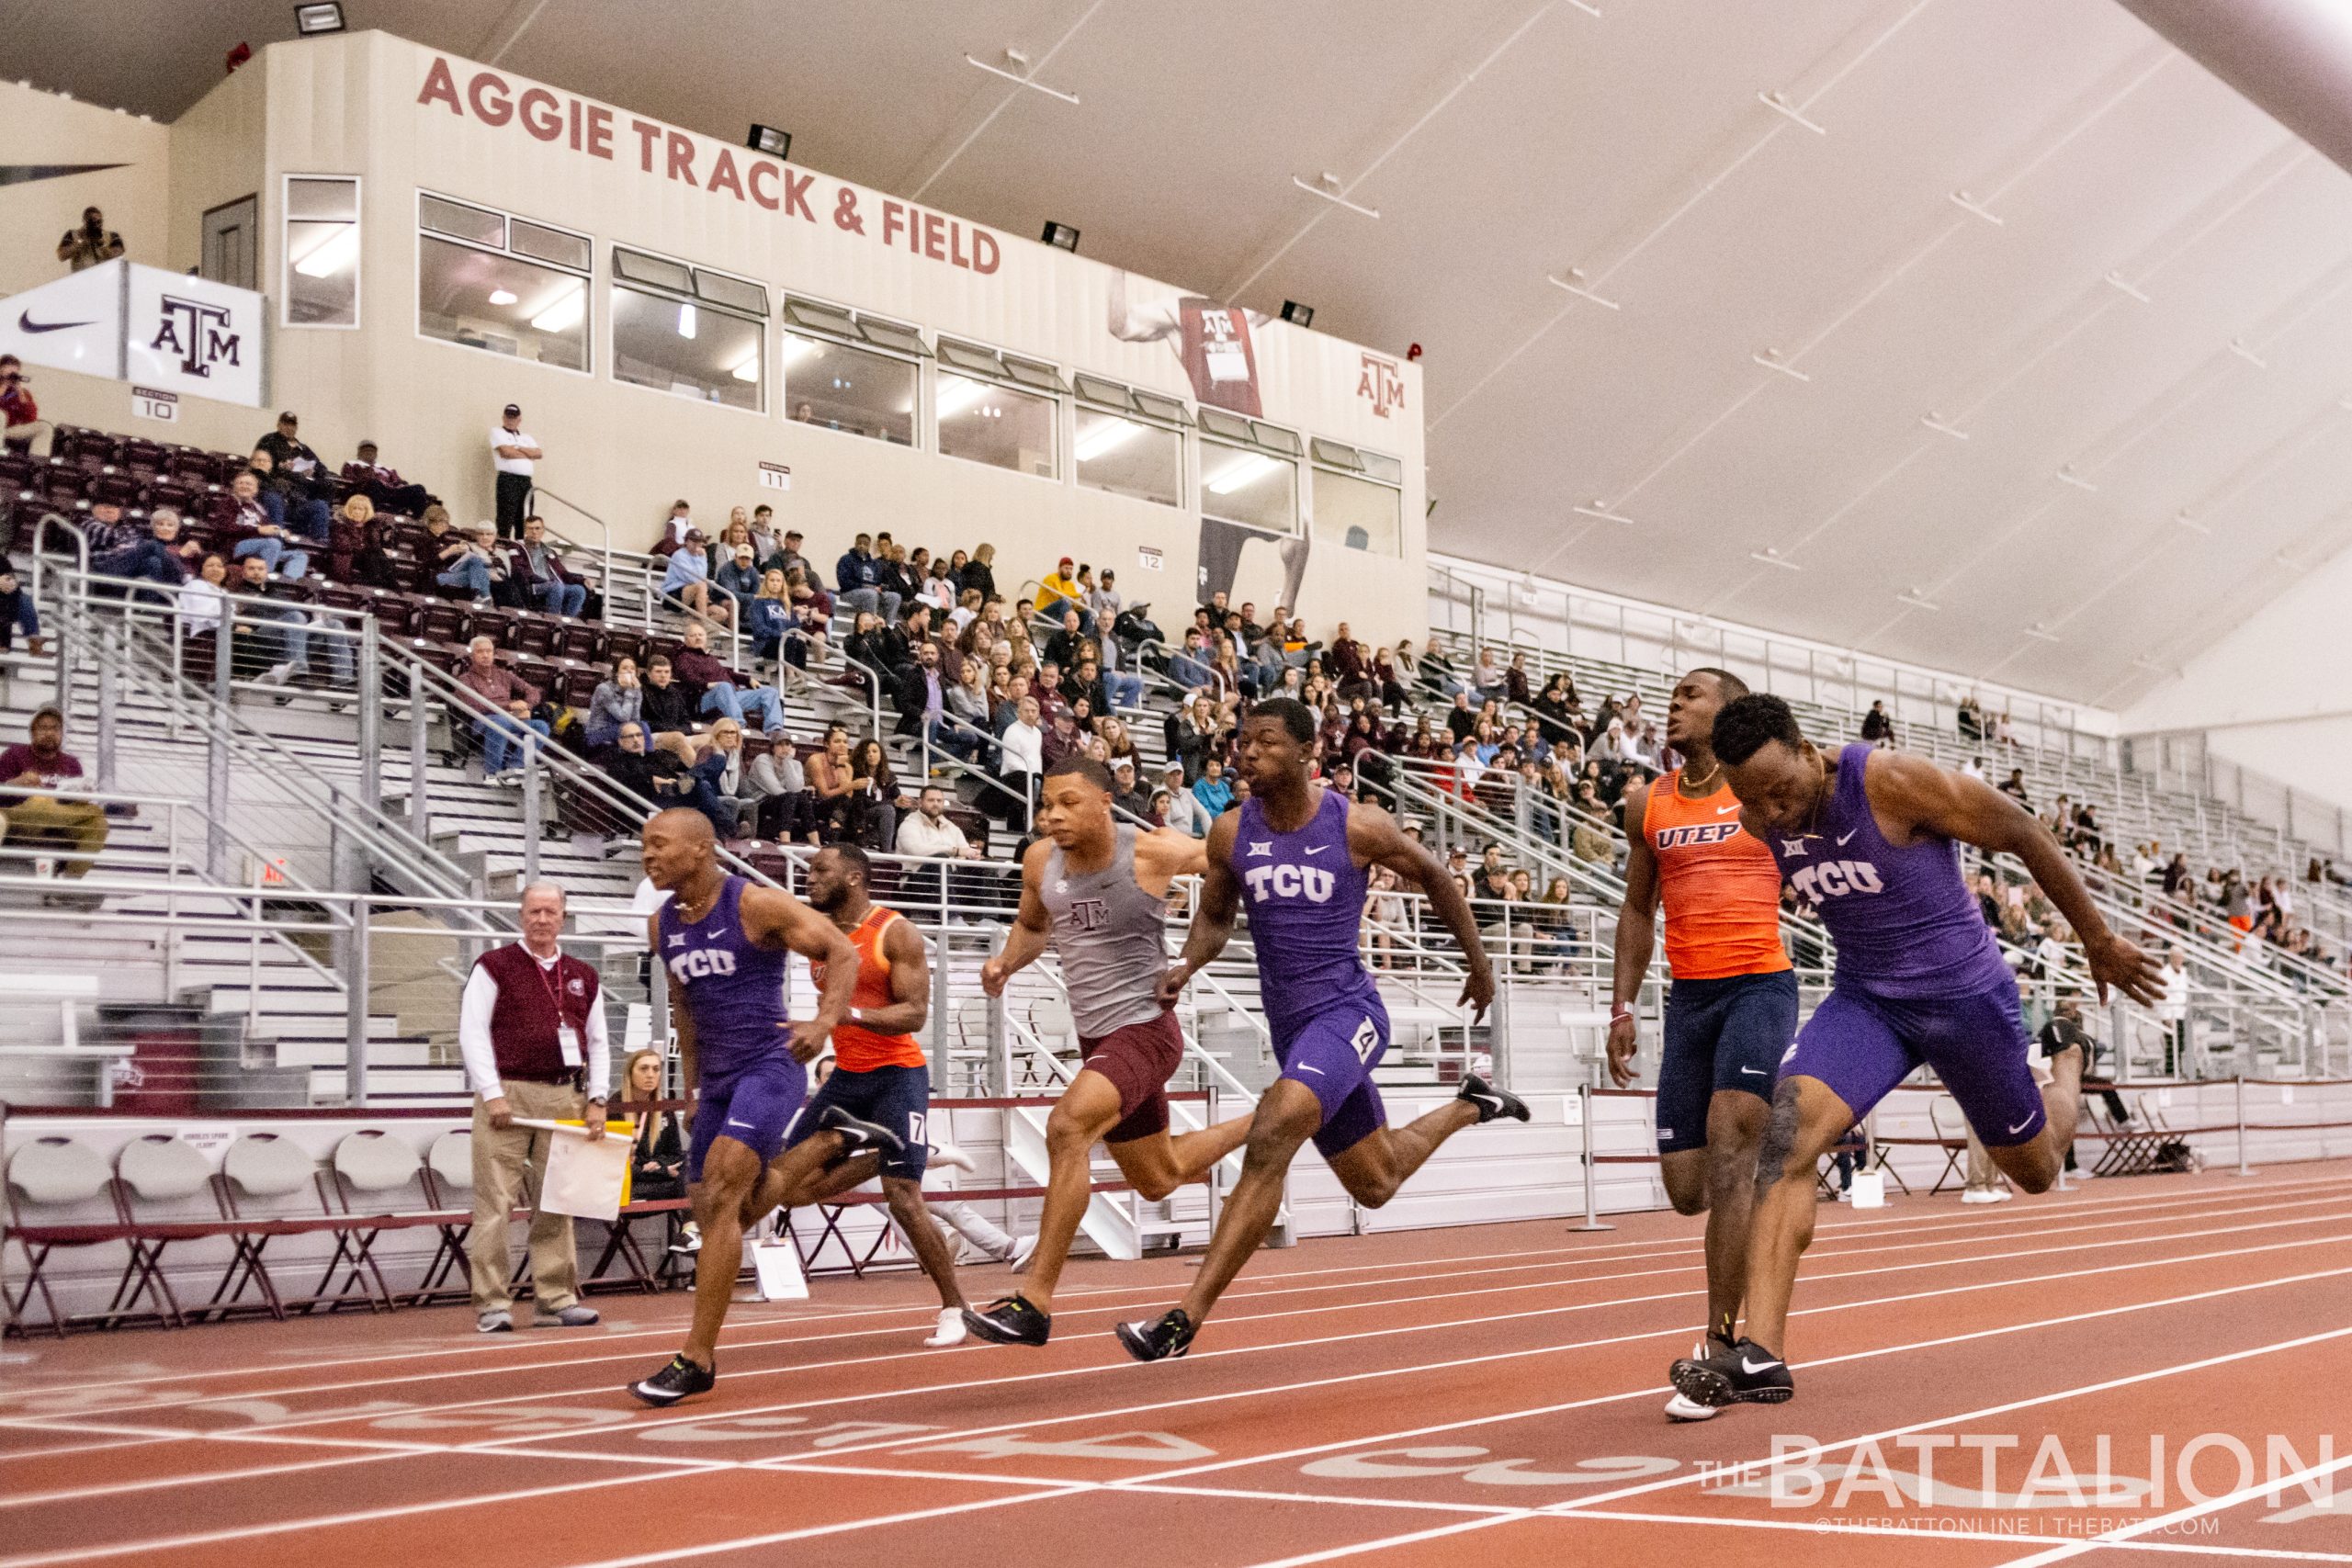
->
[1769,745,2016,997]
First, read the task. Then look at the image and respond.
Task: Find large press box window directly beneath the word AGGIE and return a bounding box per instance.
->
[416,193,593,371]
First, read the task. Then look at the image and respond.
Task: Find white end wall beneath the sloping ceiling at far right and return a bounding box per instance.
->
[2121,552,2352,808]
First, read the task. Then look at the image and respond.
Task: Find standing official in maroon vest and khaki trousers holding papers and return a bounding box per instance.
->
[457,882,612,1333]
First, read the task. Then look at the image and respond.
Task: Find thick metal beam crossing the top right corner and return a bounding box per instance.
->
[2121,0,2352,169]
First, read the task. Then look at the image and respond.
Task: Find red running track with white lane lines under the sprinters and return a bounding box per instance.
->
[0,1161,2352,1568]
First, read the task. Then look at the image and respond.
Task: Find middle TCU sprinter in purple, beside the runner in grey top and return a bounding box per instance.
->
[1117,698,1526,1361]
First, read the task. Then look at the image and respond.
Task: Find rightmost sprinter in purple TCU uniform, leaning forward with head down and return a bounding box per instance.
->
[1670,694,2159,1405]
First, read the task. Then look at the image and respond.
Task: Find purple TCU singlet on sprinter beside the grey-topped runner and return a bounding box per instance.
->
[1232,790,1378,1037]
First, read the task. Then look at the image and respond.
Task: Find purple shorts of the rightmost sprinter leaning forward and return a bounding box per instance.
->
[1781,983,2046,1149]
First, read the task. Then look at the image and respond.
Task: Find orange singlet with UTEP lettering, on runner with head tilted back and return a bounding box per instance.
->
[1642,769,1790,980]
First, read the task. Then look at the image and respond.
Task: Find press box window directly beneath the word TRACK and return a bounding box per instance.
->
[611,240,767,413]
